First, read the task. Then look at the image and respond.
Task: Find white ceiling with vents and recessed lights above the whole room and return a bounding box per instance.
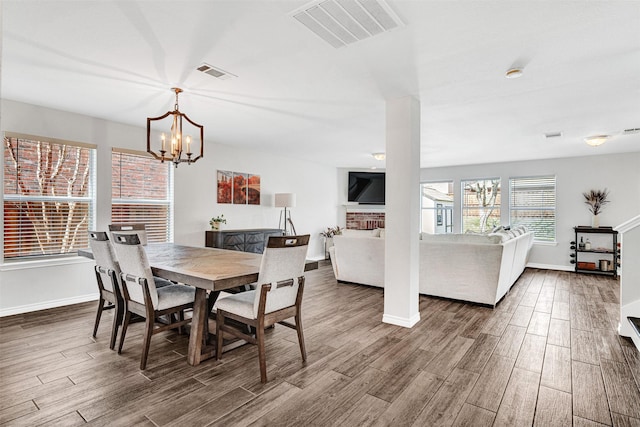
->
[1,0,640,167]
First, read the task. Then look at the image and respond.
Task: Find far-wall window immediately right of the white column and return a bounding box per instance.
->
[420,181,453,234]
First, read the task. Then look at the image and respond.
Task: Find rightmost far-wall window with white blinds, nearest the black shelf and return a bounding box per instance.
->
[509,176,556,242]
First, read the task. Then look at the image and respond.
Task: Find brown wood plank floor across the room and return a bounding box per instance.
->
[0,264,640,426]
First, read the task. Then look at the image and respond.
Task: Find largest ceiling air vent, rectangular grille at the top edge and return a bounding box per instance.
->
[290,0,404,48]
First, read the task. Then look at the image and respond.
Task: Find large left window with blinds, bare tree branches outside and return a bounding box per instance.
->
[3,132,96,260]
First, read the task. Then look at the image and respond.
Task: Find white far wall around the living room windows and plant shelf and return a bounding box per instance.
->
[420,155,640,270]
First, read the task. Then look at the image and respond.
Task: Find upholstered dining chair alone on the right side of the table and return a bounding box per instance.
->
[216,234,309,383]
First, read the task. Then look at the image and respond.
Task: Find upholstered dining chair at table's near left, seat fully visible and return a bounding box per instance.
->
[113,233,195,370]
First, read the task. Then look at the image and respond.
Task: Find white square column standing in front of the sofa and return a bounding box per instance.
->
[382,96,420,328]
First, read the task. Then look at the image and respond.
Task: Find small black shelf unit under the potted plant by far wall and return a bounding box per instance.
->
[570,225,620,278]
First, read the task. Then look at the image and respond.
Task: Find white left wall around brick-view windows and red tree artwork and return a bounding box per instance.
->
[0,100,337,316]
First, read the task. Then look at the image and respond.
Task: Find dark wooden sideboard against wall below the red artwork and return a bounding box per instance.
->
[204,228,282,254]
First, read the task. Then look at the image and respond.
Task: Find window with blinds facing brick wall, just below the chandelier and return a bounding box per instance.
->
[111,149,173,242]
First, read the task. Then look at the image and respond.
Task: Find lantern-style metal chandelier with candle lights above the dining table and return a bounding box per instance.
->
[147,87,204,167]
